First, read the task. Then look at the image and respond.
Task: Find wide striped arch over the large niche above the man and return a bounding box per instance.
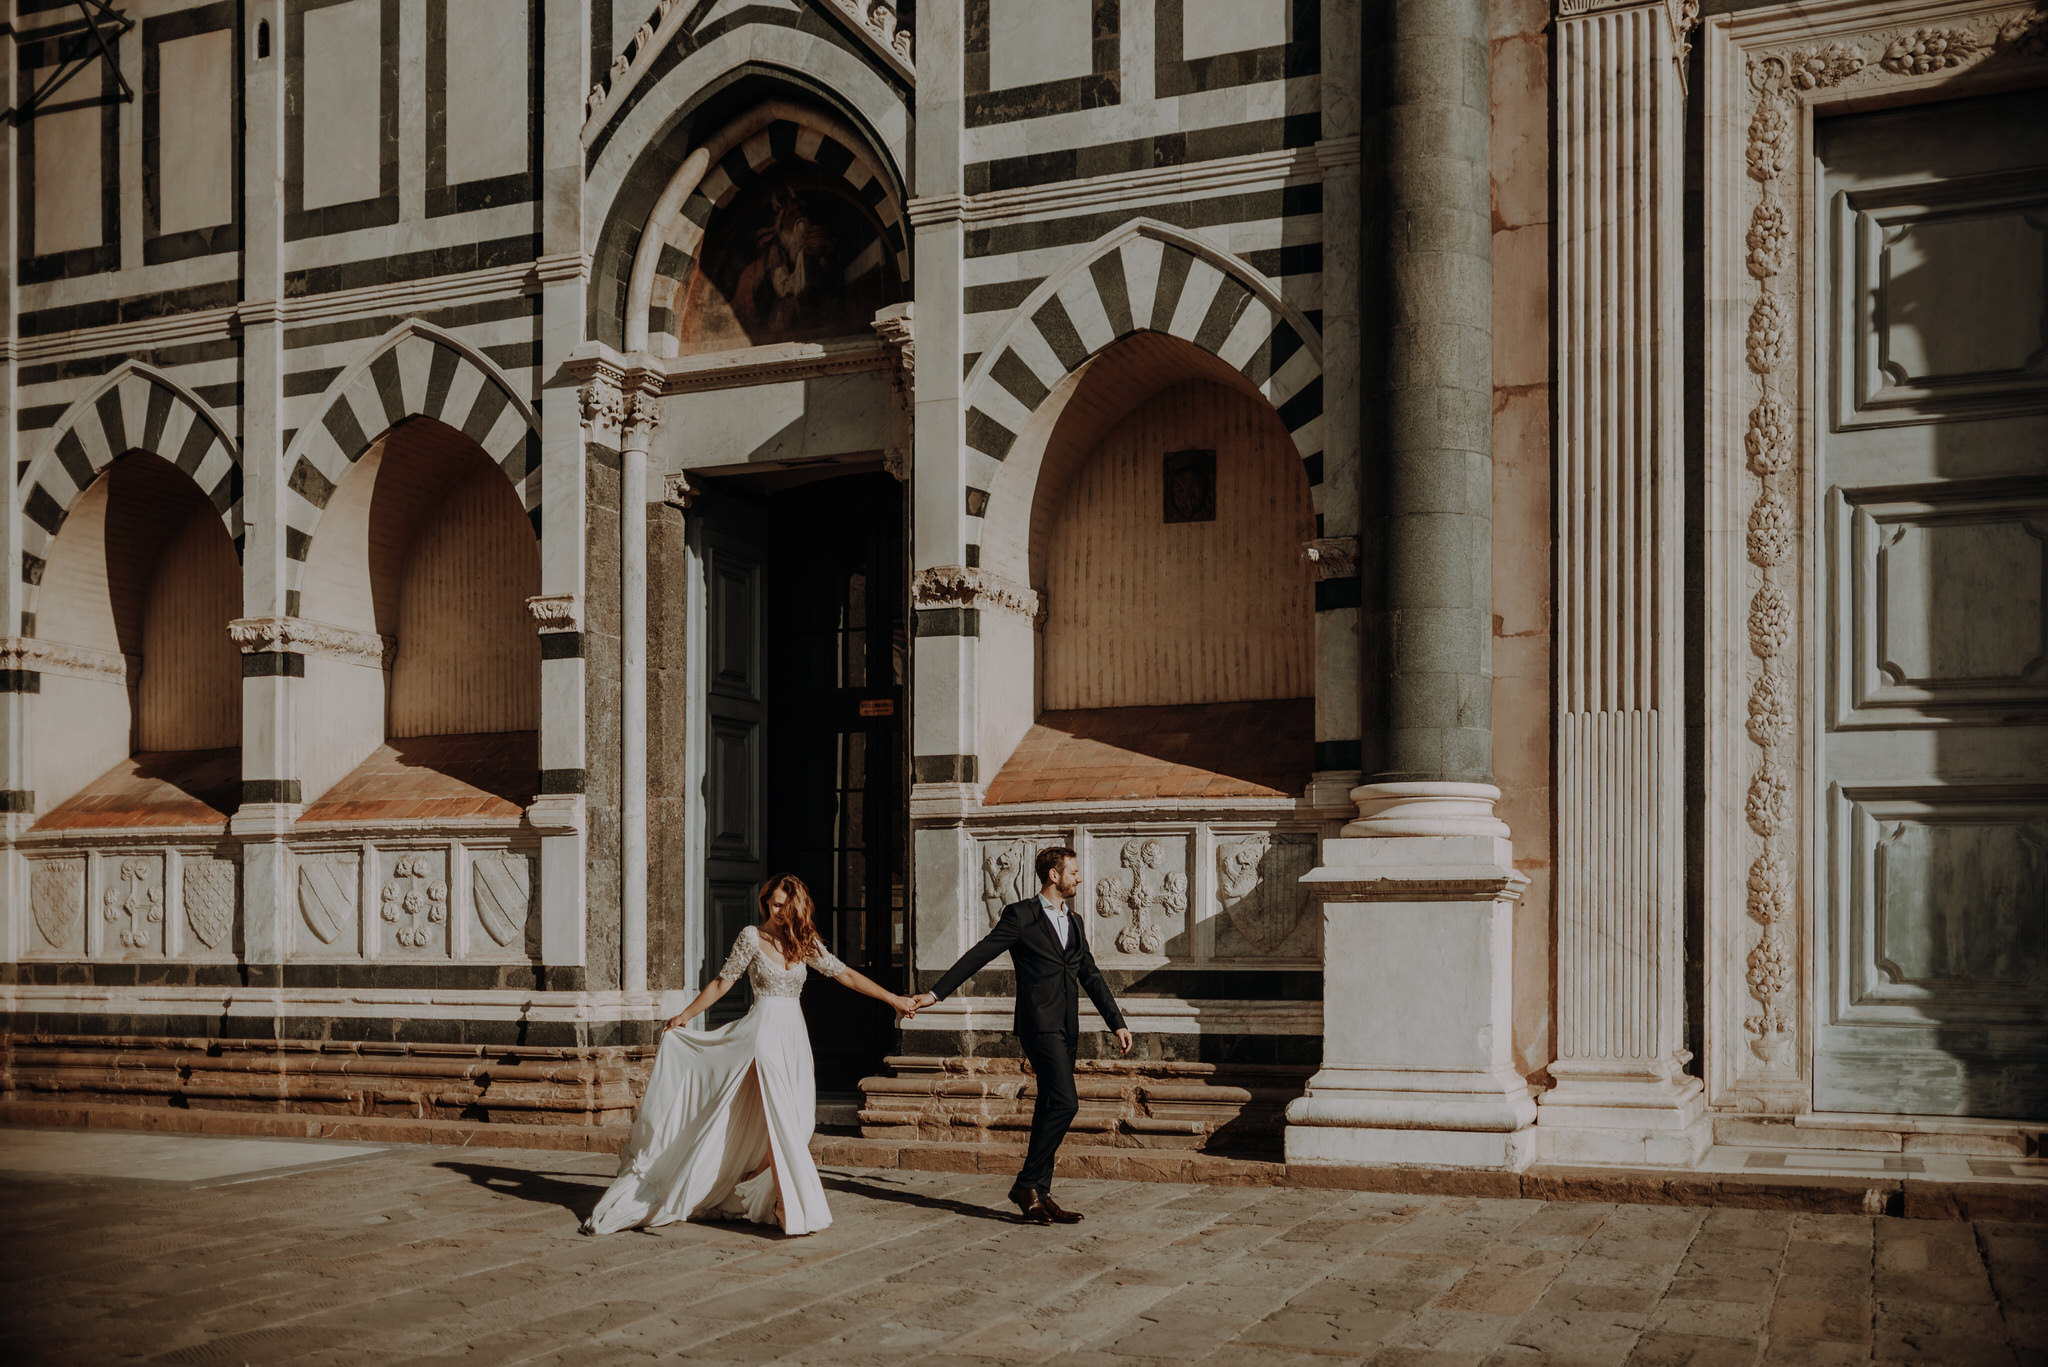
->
[967,219,1323,498]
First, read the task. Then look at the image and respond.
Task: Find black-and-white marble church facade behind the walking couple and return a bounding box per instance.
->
[0,0,2048,1168]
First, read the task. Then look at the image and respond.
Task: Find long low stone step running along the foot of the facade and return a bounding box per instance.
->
[0,1101,2048,1224]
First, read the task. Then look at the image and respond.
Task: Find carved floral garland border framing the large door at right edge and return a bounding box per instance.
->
[1743,10,2048,1068]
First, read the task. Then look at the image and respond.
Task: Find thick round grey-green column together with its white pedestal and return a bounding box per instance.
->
[1286,0,1536,1168]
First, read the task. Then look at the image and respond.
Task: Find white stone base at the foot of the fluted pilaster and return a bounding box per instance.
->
[1536,1068,1714,1168]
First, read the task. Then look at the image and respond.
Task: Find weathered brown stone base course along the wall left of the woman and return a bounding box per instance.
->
[0,1033,651,1125]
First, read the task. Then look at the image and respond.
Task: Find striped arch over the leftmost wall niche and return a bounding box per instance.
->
[16,361,242,611]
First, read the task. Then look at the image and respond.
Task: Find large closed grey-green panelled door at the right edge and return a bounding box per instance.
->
[1810,92,2048,1119]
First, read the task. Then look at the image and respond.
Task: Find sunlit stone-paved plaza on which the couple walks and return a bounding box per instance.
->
[0,1131,2048,1367]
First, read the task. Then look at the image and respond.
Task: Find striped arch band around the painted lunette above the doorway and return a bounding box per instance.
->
[647,119,909,357]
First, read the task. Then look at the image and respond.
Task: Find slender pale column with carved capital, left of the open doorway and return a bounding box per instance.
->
[618,371,662,992]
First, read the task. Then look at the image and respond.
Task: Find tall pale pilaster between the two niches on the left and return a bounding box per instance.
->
[229,0,305,986]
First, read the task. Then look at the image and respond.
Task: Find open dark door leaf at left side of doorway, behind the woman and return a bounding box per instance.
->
[698,492,768,1021]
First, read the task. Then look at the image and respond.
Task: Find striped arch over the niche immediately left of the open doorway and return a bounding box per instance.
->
[285,322,541,590]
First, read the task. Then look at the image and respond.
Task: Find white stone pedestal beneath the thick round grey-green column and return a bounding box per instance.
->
[1286,819,1536,1170]
